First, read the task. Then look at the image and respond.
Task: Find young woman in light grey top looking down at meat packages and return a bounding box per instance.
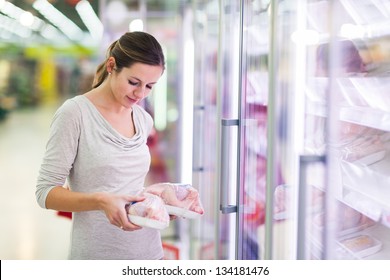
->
[36,32,165,259]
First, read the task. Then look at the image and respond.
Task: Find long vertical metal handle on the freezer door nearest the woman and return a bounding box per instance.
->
[220,119,239,214]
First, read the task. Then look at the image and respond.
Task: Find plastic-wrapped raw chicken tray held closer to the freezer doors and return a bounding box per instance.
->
[146,183,204,219]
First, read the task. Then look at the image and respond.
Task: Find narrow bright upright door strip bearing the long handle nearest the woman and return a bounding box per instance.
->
[217,0,242,259]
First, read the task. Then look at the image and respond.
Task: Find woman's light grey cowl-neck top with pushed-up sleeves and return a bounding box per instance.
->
[36,95,163,260]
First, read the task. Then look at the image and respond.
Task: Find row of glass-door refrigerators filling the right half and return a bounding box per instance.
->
[190,0,390,259]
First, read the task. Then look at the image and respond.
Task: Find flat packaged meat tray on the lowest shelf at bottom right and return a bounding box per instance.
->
[339,234,382,258]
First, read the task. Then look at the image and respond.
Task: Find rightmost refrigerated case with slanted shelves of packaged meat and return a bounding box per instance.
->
[300,0,390,259]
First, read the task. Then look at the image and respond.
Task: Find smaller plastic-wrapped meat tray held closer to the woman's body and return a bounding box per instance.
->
[128,192,169,229]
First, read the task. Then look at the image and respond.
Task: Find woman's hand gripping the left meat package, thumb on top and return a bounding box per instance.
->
[101,193,145,231]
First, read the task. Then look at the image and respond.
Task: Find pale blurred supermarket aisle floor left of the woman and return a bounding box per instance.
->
[0,106,71,260]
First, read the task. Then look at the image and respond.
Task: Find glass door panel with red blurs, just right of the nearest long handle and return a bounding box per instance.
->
[237,1,269,260]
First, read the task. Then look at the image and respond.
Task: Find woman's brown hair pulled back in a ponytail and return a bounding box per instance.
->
[92,31,165,88]
